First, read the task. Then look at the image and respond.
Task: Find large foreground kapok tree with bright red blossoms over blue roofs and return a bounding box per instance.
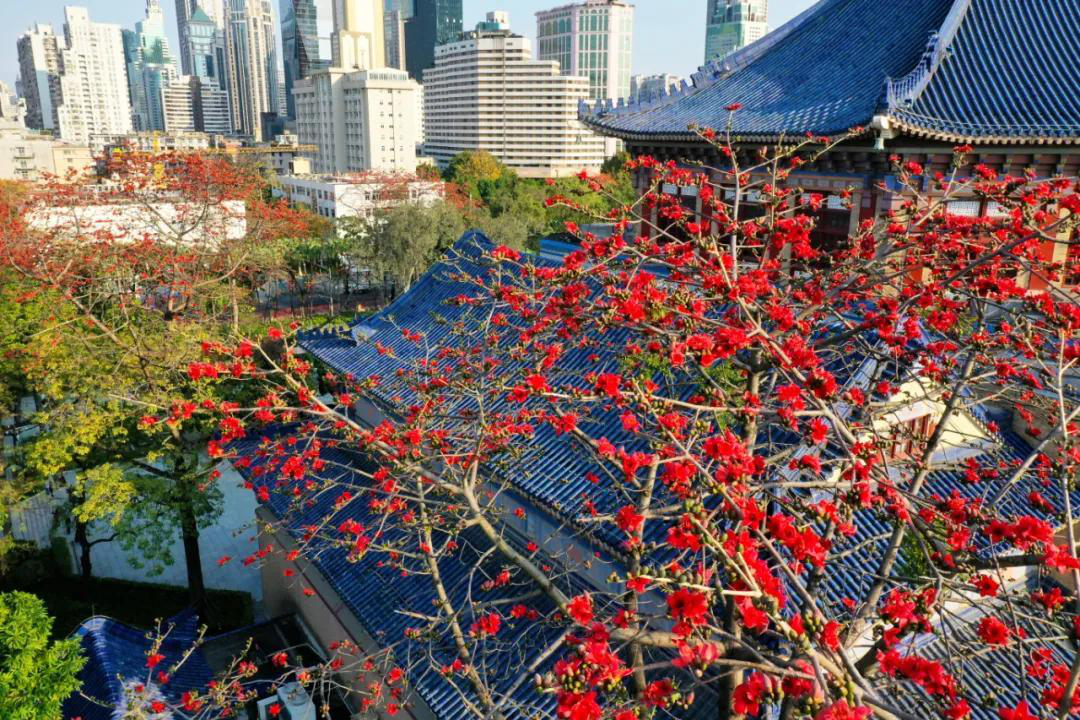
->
[122,126,1080,720]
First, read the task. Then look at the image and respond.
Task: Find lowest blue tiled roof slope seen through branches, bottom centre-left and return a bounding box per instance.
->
[230,439,711,720]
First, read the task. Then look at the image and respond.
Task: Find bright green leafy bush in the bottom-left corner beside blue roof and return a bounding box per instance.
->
[0,593,86,720]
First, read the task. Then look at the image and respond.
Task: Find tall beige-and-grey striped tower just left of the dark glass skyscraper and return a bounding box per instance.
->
[225,0,286,141]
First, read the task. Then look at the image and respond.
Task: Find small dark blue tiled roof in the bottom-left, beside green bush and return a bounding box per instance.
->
[64,613,213,720]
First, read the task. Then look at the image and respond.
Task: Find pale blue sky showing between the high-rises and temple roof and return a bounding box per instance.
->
[0,0,813,87]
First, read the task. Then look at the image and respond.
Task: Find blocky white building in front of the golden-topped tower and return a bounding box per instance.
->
[293,68,420,173]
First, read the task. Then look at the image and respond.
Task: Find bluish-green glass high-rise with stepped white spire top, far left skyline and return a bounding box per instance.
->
[123,0,179,132]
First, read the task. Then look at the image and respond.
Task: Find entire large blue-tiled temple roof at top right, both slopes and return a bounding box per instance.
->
[581,0,1080,142]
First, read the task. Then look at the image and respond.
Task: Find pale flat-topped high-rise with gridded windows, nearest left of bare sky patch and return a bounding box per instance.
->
[537,0,634,100]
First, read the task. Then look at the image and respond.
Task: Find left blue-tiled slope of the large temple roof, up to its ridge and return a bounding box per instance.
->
[583,0,950,139]
